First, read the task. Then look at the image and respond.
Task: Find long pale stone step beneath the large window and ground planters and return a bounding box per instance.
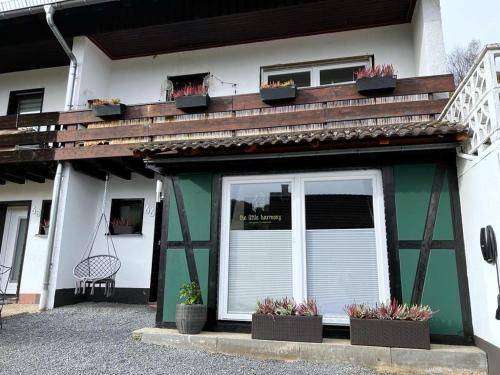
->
[132,328,488,375]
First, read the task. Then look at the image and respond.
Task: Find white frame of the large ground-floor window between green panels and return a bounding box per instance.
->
[218,170,390,325]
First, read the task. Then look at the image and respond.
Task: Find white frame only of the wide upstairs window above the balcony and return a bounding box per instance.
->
[261,56,373,87]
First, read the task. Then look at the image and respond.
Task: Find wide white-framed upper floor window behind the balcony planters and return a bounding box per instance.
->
[262,56,372,87]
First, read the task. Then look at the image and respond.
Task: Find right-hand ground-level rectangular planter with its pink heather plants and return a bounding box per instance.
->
[346,300,433,349]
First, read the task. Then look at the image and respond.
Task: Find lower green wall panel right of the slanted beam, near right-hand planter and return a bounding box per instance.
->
[422,250,463,336]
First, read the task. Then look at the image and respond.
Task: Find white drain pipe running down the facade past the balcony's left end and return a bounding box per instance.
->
[39,5,77,311]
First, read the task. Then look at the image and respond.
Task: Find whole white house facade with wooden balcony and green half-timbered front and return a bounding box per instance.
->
[0,0,500,370]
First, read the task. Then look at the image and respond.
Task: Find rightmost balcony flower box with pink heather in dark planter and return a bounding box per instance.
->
[356,65,397,94]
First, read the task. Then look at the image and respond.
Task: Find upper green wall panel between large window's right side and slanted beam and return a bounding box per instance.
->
[394,164,436,240]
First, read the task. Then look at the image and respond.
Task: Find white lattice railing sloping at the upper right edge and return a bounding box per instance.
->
[440,44,500,155]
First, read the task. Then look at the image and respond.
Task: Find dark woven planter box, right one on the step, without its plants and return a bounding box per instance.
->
[350,318,431,349]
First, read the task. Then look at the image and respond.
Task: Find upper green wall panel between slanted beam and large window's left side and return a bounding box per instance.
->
[180,174,212,241]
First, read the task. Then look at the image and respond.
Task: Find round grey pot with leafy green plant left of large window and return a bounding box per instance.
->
[175,282,207,335]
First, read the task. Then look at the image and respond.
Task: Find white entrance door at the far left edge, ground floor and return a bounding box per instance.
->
[0,207,28,294]
